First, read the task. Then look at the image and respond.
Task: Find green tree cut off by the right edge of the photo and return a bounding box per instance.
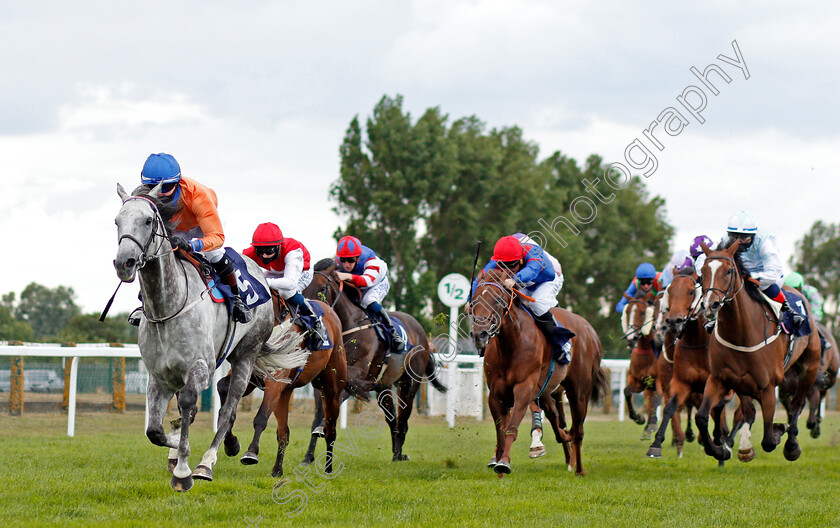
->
[790,220,840,333]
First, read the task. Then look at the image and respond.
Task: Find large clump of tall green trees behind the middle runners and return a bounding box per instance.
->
[331,96,673,353]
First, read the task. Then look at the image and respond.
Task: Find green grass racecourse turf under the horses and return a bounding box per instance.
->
[0,413,840,528]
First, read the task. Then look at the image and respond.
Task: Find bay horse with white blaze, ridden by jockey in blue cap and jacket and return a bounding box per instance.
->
[621,292,662,440]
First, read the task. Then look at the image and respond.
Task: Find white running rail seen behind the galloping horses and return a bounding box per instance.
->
[0,343,630,436]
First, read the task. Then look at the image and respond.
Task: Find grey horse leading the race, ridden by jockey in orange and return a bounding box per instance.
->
[114,184,284,491]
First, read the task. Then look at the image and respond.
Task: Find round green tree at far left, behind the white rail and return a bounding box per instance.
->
[12,282,81,341]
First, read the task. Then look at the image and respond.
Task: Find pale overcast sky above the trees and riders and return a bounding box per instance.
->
[0,0,840,313]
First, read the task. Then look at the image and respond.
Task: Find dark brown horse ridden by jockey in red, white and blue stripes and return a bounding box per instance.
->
[303,258,446,464]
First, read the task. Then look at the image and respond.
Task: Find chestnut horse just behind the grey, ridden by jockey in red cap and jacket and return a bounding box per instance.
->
[219,291,347,477]
